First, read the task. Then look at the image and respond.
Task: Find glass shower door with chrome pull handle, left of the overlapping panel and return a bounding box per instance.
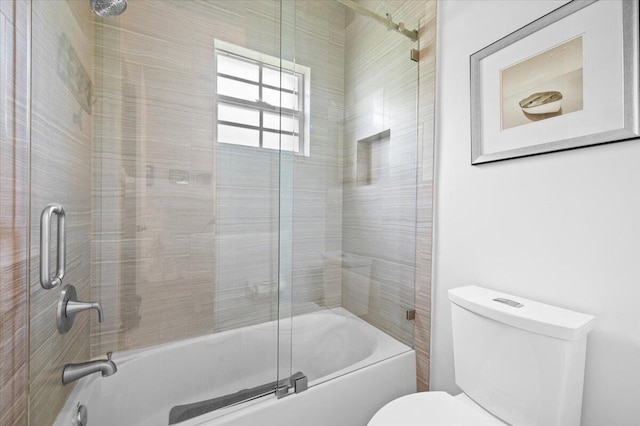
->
[30,0,295,425]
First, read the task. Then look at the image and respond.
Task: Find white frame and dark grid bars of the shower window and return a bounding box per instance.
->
[214,40,311,157]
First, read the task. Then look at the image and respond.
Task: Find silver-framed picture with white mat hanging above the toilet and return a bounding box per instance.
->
[471,0,640,164]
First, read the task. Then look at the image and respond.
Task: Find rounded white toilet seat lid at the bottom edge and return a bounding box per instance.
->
[367,392,506,426]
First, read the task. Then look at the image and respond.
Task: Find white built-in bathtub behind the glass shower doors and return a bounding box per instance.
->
[54,308,416,426]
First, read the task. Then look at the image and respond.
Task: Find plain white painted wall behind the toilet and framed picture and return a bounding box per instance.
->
[431,0,640,426]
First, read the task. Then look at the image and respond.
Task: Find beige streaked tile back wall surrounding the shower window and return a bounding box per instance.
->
[92,0,344,355]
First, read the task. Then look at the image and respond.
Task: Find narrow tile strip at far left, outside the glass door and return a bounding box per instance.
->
[0,1,29,425]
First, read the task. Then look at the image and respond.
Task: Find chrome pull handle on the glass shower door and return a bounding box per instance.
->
[40,203,66,290]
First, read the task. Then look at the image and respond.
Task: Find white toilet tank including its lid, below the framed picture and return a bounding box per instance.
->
[449,286,595,426]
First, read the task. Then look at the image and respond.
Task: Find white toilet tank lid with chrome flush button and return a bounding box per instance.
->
[449,285,595,340]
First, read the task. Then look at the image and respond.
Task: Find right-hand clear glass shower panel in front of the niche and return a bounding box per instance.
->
[283,2,422,392]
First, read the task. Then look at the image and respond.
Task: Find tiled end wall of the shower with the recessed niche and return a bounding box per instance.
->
[342,1,419,345]
